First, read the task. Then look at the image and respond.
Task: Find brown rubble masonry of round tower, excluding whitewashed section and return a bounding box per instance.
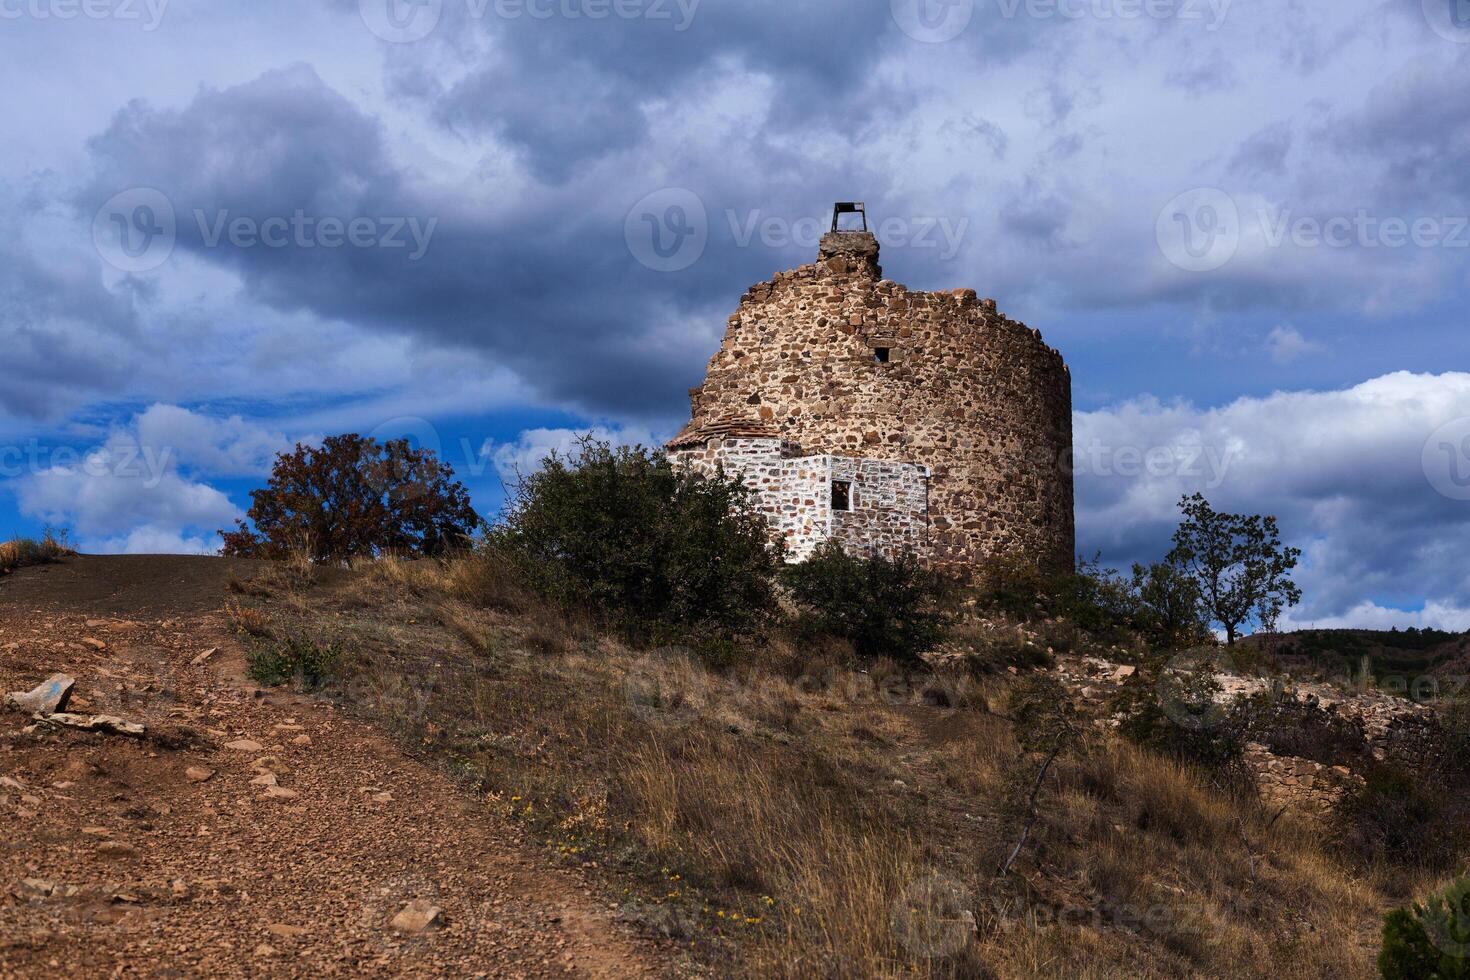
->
[673,232,1075,576]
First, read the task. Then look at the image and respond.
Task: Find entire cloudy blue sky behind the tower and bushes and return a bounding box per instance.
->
[0,0,1470,629]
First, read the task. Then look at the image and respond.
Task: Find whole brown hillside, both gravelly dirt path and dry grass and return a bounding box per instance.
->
[0,557,1458,977]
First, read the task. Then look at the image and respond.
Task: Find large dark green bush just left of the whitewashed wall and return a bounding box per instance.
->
[488,438,781,658]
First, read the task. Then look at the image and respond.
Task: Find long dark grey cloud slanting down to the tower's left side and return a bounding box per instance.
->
[79,66,905,414]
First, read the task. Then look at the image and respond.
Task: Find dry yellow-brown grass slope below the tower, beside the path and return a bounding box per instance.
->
[249,558,1434,980]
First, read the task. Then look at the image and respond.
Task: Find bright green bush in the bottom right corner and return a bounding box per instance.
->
[1377,877,1470,980]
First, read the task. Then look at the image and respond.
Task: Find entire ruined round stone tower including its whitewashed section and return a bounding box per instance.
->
[667,204,1075,579]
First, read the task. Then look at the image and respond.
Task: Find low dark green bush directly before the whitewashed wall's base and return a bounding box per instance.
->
[781,541,953,664]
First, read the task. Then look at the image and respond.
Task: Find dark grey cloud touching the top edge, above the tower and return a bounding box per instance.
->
[391,0,1046,182]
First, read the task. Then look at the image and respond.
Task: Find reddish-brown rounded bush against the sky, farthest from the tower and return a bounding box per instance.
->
[219,433,479,563]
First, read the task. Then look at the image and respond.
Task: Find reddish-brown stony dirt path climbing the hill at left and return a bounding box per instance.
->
[0,558,666,977]
